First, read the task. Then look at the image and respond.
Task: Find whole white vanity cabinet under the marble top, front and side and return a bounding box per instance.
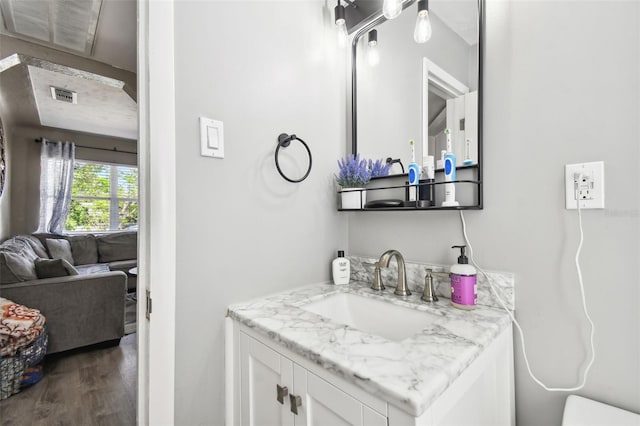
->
[225,318,515,426]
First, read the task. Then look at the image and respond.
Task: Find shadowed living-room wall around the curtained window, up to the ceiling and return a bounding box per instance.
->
[0,35,137,241]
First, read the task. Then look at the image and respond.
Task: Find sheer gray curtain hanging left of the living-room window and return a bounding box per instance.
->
[38,138,76,234]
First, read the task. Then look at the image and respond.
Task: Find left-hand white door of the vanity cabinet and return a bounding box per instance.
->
[240,333,294,426]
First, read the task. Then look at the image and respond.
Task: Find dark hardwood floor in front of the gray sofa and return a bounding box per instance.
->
[0,333,137,426]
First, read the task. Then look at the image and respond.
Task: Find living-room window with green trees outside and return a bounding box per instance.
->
[65,161,138,232]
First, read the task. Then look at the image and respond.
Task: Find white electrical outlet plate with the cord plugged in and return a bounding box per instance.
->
[564,161,604,210]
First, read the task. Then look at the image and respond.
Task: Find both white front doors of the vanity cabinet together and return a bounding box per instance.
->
[236,332,387,426]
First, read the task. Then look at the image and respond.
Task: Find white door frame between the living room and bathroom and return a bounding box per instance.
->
[137,0,176,425]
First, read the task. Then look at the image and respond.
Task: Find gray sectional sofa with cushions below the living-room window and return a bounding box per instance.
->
[0,232,137,354]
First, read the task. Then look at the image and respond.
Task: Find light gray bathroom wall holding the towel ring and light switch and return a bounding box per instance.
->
[175,1,347,425]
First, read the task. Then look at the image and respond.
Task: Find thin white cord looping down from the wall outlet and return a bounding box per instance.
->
[460,202,596,392]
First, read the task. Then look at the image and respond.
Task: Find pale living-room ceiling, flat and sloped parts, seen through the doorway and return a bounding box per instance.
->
[0,0,137,140]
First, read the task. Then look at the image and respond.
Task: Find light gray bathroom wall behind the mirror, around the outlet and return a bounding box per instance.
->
[349,1,640,426]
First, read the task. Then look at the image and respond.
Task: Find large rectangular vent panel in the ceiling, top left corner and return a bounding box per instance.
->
[0,0,102,55]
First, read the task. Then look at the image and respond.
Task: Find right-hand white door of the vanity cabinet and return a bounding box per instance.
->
[293,364,387,426]
